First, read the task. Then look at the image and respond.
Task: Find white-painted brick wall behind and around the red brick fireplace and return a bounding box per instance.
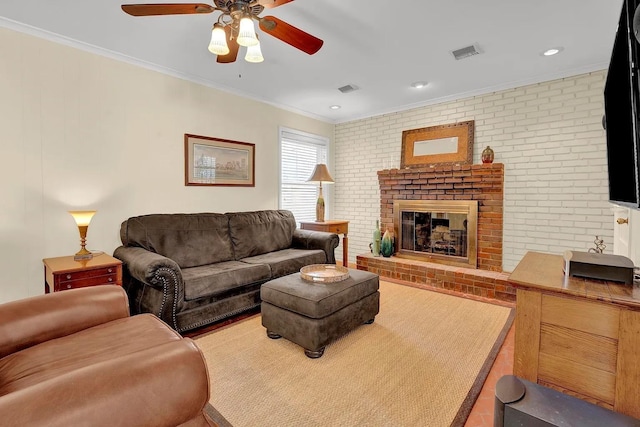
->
[332,71,613,271]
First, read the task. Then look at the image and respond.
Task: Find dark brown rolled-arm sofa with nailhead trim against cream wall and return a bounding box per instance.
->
[113,210,339,332]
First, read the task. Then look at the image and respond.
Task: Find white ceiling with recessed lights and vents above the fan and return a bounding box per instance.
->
[0,0,622,123]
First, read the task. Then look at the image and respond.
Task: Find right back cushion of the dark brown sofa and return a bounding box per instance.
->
[226,210,296,261]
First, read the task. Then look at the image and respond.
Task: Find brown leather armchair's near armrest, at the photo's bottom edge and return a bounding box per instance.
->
[0,339,209,427]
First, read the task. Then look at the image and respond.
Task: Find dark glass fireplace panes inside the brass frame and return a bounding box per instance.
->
[401,211,467,257]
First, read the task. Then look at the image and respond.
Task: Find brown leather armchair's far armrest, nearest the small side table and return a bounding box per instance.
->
[0,285,129,359]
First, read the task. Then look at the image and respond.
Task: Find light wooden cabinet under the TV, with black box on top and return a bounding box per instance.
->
[509,252,640,418]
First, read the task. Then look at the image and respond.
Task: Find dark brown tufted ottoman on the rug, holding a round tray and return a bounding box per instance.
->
[260,269,380,359]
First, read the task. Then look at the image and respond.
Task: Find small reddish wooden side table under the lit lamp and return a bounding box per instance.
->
[42,254,122,294]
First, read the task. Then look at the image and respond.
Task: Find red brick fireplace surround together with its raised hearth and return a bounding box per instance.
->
[356,163,515,301]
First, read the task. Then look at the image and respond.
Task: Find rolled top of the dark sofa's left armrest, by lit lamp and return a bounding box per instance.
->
[113,246,182,288]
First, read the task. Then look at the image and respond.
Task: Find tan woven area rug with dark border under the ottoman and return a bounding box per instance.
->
[196,282,514,427]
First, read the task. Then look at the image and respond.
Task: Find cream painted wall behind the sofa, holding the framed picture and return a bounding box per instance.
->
[0,28,334,302]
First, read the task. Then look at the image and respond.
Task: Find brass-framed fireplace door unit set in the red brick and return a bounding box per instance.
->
[393,200,478,268]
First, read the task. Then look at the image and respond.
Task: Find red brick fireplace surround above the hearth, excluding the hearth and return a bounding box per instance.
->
[378,163,504,271]
